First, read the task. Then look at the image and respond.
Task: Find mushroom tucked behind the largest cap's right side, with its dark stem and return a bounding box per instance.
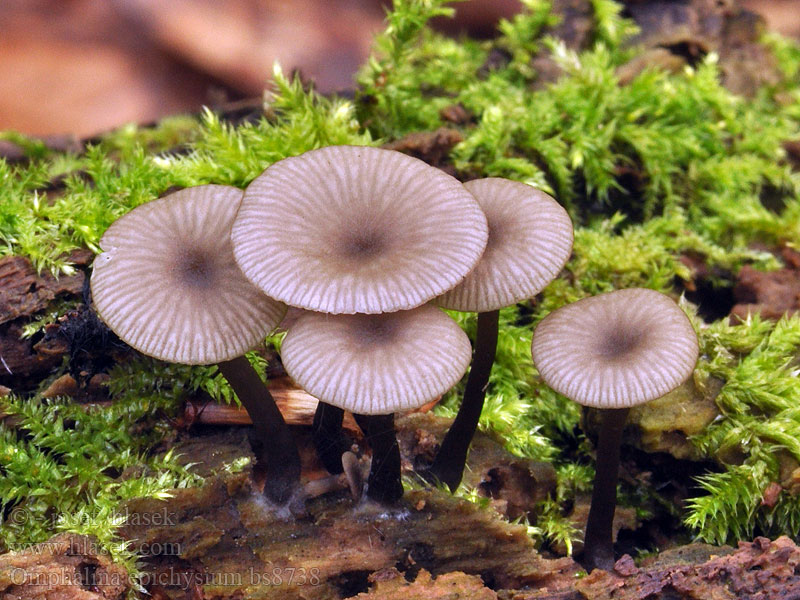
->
[427,177,573,491]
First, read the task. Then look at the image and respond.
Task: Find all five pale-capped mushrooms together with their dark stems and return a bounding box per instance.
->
[91,146,698,568]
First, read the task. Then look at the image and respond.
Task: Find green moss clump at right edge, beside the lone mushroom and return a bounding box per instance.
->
[685,317,800,543]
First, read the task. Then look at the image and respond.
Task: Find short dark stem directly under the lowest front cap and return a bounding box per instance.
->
[353,413,403,504]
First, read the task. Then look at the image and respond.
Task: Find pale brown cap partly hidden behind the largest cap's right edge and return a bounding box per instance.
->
[436,177,573,312]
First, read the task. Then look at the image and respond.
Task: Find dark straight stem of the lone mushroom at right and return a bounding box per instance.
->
[583,408,629,572]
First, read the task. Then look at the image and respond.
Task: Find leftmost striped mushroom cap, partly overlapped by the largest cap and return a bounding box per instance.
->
[91,185,286,364]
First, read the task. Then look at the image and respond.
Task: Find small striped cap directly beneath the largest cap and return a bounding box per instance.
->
[281,304,472,414]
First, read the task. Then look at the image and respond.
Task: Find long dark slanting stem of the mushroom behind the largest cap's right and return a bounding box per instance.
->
[428,310,500,492]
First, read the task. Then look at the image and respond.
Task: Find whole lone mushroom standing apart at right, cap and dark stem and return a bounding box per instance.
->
[532,288,699,570]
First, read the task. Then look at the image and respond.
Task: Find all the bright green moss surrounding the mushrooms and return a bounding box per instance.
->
[0,0,800,572]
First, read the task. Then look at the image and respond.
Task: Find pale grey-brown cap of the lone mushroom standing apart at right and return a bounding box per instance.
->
[532,288,699,408]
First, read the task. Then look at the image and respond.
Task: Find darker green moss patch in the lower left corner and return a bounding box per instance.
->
[0,386,198,569]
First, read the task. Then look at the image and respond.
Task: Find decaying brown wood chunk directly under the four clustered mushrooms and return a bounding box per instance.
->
[109,414,568,598]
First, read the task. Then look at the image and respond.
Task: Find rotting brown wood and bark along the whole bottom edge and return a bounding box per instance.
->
[7,414,800,600]
